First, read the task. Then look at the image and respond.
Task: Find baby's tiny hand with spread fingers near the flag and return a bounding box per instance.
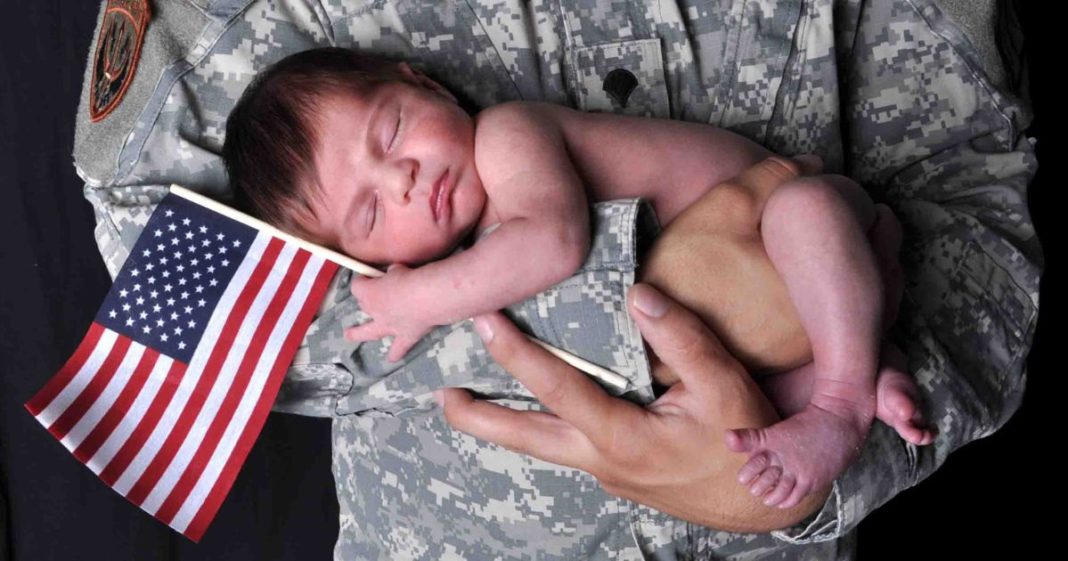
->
[345,265,434,362]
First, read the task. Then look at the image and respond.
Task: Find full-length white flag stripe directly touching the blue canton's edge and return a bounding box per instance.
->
[113,233,270,497]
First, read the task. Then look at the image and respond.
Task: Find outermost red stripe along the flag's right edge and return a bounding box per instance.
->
[185,261,337,542]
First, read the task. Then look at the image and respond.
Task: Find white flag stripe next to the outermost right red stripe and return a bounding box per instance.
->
[171,255,324,532]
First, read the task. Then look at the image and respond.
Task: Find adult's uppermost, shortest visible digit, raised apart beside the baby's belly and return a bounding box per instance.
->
[627,283,742,400]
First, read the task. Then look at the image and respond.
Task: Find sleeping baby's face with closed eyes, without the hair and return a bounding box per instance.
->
[304,66,486,265]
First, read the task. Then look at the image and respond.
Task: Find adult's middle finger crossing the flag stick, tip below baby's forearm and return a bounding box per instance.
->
[474,312,644,447]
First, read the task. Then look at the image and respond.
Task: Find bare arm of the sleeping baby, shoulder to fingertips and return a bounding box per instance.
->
[348,104,590,360]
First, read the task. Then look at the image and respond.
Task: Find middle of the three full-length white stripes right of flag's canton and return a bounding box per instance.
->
[141,244,297,514]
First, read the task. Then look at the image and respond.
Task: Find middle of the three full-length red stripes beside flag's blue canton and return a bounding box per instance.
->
[156,247,310,525]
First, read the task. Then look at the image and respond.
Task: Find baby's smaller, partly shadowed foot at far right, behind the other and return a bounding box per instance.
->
[875,342,937,446]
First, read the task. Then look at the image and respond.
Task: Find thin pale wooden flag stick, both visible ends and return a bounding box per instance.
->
[171,185,627,389]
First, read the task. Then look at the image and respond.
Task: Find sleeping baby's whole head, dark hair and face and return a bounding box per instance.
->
[228,48,486,265]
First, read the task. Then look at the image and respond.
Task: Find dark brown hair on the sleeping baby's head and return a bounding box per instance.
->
[222,47,402,235]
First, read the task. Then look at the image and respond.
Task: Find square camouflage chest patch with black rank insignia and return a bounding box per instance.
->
[572,38,671,119]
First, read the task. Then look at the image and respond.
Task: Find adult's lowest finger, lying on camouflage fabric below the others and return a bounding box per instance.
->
[440,388,596,471]
